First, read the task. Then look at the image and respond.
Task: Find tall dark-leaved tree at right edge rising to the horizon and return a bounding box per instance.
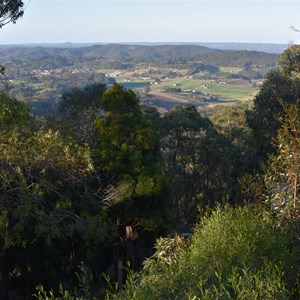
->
[246,46,300,167]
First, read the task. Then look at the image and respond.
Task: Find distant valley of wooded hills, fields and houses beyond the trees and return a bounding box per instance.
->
[0,44,279,115]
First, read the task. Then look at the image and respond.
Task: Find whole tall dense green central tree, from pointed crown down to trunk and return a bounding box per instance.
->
[92,84,169,269]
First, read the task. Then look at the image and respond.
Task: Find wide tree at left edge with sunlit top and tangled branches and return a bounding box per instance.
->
[0,95,112,299]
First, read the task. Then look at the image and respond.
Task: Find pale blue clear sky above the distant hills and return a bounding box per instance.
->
[0,0,300,44]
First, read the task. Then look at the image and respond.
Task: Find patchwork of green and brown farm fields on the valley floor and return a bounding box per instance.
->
[115,68,259,105]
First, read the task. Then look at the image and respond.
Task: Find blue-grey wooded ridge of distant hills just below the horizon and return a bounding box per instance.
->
[0,44,279,67]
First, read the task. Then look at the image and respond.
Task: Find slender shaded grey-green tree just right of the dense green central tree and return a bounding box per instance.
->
[161,106,210,228]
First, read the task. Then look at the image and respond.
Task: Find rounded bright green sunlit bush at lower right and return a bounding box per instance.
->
[189,208,288,277]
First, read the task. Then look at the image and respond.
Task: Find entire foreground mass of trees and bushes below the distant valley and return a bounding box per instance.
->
[0,41,300,299]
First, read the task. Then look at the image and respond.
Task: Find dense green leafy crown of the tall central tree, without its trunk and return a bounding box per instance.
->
[94,84,167,230]
